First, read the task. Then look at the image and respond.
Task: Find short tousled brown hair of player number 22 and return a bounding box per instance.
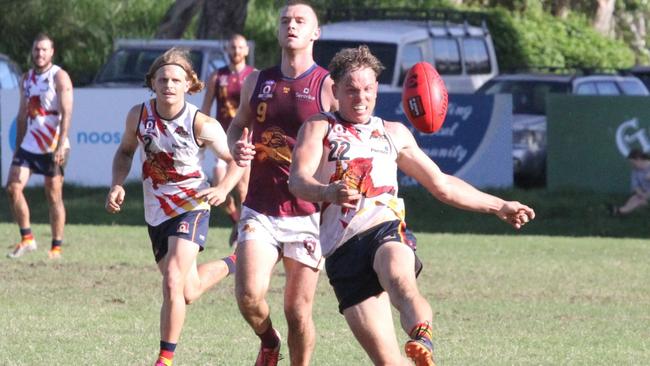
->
[328,45,385,83]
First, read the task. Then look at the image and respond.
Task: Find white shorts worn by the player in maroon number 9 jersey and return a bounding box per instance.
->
[237,206,325,269]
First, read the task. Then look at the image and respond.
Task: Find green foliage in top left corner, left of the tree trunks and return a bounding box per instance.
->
[0,0,173,82]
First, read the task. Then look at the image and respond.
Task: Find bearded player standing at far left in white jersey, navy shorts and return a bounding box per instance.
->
[7,34,73,259]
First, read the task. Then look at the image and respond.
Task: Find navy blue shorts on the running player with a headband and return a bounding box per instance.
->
[147,210,210,263]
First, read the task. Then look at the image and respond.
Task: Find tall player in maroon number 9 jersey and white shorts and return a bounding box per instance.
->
[228,1,336,365]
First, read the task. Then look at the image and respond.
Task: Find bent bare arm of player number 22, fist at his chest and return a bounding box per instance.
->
[289,115,361,208]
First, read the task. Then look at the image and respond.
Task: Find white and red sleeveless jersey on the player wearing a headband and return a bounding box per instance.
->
[137,99,210,226]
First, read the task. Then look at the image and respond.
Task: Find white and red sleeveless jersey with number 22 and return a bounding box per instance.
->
[316,113,404,256]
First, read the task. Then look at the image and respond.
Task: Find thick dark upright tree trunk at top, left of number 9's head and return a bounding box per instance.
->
[196,0,248,39]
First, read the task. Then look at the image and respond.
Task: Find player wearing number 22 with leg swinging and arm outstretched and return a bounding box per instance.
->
[289,46,535,365]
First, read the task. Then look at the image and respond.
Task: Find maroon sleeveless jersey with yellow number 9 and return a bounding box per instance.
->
[244,65,328,216]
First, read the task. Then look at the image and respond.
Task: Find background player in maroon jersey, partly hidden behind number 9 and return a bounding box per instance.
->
[201,34,255,245]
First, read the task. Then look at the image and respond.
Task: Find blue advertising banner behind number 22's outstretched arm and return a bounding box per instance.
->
[375,93,512,188]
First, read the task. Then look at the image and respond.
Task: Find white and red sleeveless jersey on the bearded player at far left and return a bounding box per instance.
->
[20,65,70,154]
